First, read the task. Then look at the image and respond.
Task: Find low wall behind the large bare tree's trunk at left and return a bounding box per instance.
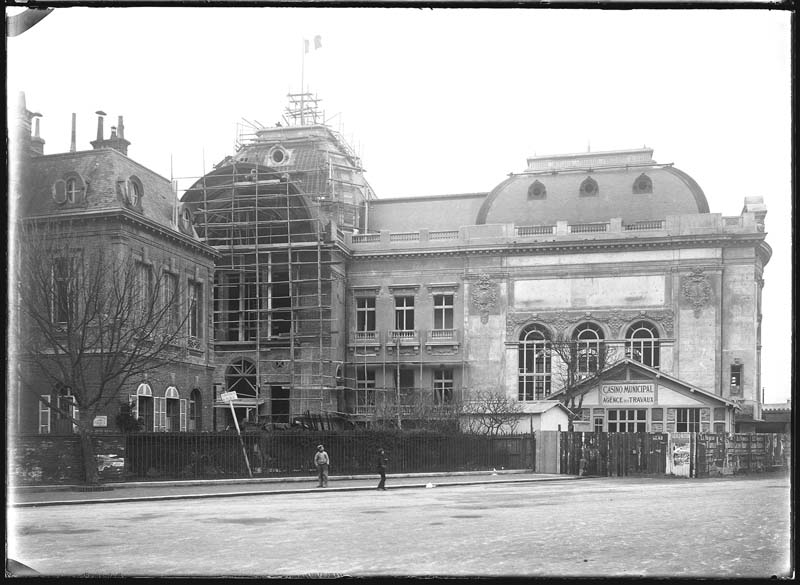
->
[6,435,125,485]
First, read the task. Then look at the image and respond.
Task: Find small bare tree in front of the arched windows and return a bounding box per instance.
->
[547,334,619,432]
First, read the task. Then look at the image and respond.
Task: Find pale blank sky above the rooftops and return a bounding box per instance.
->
[7,7,793,402]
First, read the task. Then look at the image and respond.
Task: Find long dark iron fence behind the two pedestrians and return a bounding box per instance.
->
[125,431,534,480]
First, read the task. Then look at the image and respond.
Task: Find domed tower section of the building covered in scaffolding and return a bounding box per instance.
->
[181,94,374,428]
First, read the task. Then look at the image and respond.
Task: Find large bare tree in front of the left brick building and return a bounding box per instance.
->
[16,222,189,483]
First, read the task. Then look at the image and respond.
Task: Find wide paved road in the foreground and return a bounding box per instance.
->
[8,476,790,577]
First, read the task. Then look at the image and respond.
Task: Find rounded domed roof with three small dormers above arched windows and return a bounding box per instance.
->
[475,149,709,225]
